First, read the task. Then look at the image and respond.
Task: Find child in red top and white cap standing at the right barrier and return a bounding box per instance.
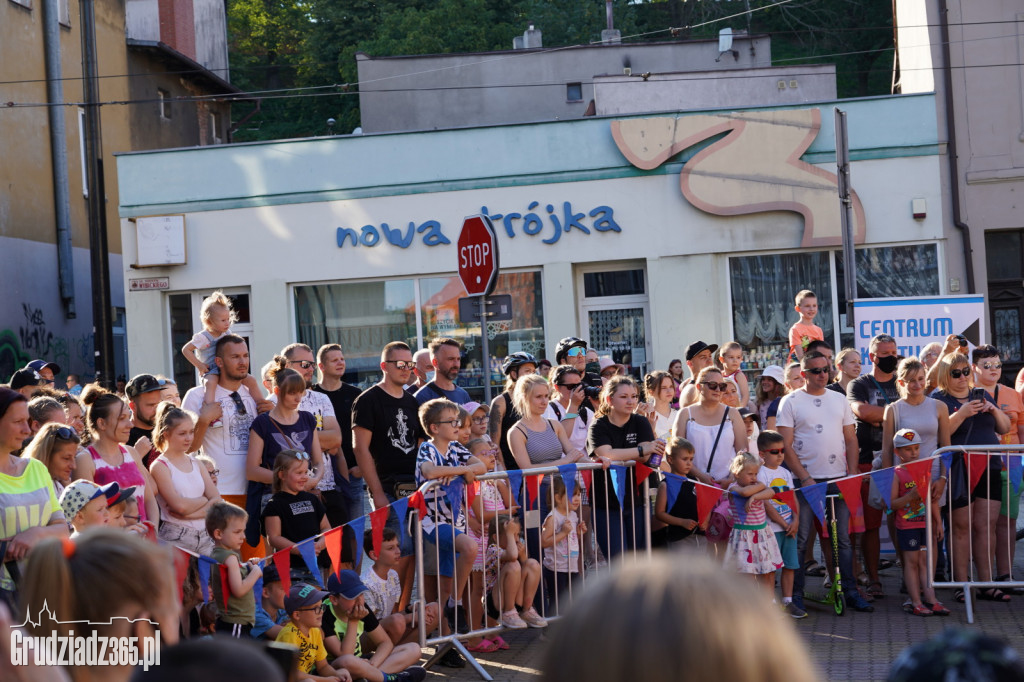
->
[892,429,949,616]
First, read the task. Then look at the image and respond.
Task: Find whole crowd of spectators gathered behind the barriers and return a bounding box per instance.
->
[0,284,1024,682]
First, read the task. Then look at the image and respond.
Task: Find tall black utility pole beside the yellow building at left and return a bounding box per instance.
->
[80,0,114,388]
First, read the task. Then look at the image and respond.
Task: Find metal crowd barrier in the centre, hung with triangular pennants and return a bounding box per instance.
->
[410,462,655,680]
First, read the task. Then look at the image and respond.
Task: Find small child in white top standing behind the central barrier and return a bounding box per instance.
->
[536,476,587,614]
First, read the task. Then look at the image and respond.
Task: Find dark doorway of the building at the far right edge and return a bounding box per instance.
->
[985,229,1024,386]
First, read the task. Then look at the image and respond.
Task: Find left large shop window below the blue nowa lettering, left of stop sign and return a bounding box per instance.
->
[295,280,419,388]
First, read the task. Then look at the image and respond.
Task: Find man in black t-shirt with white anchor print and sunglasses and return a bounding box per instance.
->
[352,341,424,609]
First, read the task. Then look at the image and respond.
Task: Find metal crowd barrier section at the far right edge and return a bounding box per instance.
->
[926,445,1024,623]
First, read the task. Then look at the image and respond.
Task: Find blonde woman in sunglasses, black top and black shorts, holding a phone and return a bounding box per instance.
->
[932,352,1010,602]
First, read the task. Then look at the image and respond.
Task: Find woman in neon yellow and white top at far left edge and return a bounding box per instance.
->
[0,387,68,613]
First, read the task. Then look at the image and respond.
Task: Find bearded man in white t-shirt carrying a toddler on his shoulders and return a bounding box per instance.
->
[181,334,270,559]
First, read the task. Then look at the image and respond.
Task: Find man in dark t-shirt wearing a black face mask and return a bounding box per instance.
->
[846,334,899,597]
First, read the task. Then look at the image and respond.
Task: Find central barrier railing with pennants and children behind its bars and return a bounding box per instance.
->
[411,462,651,680]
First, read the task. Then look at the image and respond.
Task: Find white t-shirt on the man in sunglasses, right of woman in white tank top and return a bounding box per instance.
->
[775,389,854,479]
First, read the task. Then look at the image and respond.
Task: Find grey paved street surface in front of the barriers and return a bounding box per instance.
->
[419,560,1024,682]
